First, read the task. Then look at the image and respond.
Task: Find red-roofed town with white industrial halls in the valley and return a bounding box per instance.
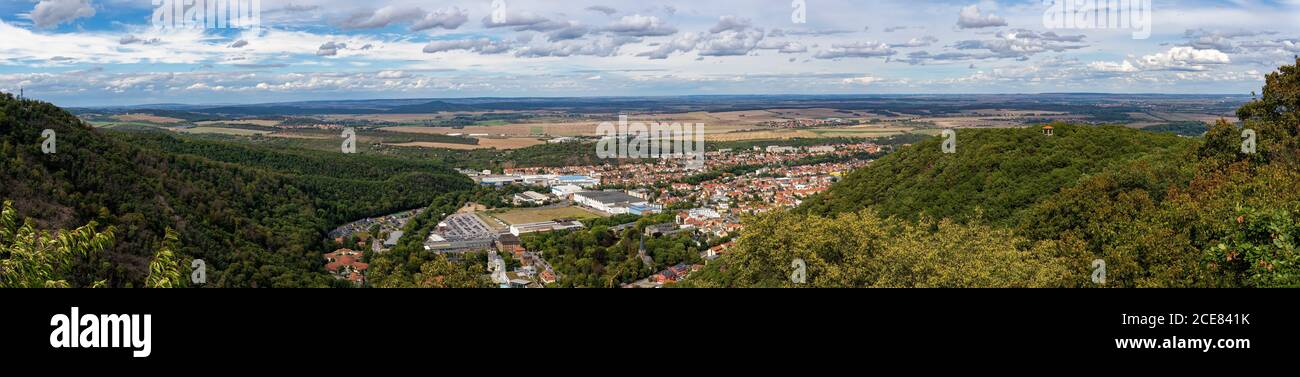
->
[325,142,885,287]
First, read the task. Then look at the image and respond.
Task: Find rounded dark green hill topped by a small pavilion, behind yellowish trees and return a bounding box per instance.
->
[800,124,1193,222]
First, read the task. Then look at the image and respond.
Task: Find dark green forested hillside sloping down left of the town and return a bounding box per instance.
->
[0,95,472,287]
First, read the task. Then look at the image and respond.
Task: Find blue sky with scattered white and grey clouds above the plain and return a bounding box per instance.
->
[0,0,1300,105]
